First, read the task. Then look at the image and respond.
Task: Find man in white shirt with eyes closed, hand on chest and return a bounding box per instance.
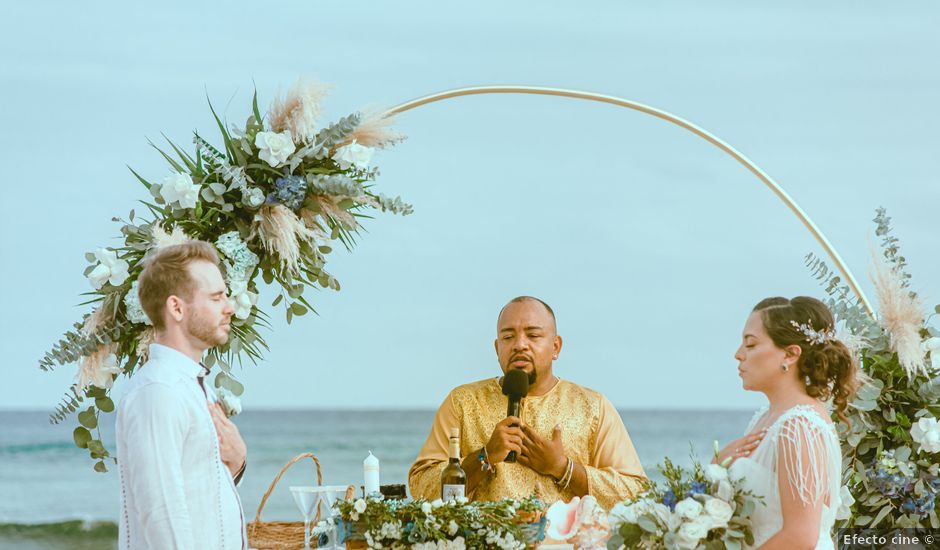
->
[116,241,247,550]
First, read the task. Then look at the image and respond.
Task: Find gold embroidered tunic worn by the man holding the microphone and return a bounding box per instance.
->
[408,378,646,509]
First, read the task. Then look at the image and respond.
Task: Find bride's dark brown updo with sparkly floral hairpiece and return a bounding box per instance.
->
[754,296,859,423]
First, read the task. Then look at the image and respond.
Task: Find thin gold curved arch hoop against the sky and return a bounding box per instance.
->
[385,86,875,317]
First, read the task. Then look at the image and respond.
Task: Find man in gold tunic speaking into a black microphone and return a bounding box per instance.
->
[408,296,646,509]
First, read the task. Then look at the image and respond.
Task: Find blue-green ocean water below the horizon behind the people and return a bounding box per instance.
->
[0,410,751,550]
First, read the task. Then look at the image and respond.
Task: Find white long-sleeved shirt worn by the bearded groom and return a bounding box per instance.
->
[116,344,246,550]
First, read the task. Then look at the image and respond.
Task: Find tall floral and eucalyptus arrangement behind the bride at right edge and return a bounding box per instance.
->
[807,208,940,529]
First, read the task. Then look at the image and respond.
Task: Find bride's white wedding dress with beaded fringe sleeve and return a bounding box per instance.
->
[729,405,842,550]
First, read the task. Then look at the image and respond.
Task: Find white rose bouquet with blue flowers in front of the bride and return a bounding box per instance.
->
[607,454,760,550]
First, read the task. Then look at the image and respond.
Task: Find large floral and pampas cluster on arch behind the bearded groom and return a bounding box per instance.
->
[39,80,412,472]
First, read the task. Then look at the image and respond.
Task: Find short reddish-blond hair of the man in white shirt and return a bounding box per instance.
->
[137,241,219,330]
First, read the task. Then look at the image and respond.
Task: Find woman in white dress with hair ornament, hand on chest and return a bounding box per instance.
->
[716,296,857,550]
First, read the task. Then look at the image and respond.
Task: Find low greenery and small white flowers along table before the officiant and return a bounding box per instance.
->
[313,497,545,550]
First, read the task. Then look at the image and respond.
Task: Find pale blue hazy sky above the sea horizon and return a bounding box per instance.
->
[0,1,940,409]
